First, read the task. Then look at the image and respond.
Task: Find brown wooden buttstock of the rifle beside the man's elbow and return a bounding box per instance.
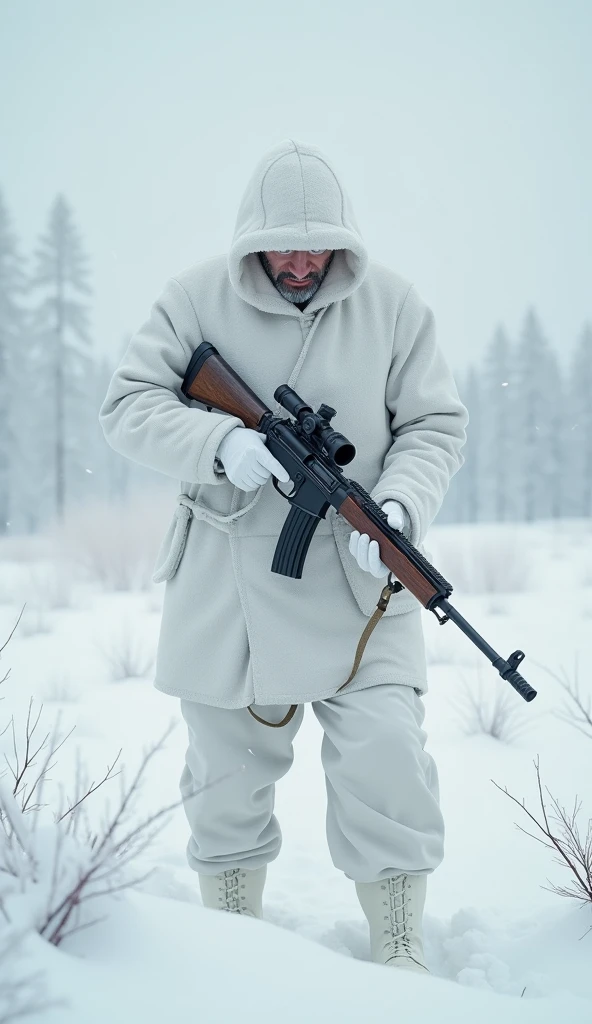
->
[183,352,269,430]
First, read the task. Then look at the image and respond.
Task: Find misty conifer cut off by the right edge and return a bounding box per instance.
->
[566,323,592,516]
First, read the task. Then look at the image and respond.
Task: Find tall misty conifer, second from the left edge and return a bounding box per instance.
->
[31,195,94,520]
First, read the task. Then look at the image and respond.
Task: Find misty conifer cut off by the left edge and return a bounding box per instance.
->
[0,193,27,534]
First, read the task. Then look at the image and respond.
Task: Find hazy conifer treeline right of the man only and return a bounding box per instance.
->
[437,308,592,523]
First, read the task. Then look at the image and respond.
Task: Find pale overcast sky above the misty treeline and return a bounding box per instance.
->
[0,0,592,372]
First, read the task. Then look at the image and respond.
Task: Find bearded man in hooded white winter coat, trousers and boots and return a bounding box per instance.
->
[99,139,468,972]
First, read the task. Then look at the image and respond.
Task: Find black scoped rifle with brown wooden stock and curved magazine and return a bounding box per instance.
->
[181,341,537,700]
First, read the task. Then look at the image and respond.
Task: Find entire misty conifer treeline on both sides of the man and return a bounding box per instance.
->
[0,186,592,535]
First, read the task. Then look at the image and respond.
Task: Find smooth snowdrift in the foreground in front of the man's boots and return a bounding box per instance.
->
[12,892,590,1024]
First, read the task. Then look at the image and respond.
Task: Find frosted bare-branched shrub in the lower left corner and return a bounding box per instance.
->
[0,618,240,962]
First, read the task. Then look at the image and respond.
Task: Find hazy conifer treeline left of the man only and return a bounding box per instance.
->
[0,191,154,535]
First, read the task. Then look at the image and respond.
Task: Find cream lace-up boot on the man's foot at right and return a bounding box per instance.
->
[355,874,429,974]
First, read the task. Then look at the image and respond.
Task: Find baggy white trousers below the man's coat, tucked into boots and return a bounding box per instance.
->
[179,683,443,882]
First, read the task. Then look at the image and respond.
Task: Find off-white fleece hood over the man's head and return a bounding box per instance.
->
[228,139,368,315]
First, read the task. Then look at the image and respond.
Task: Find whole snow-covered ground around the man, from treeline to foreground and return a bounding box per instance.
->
[0,520,592,1024]
